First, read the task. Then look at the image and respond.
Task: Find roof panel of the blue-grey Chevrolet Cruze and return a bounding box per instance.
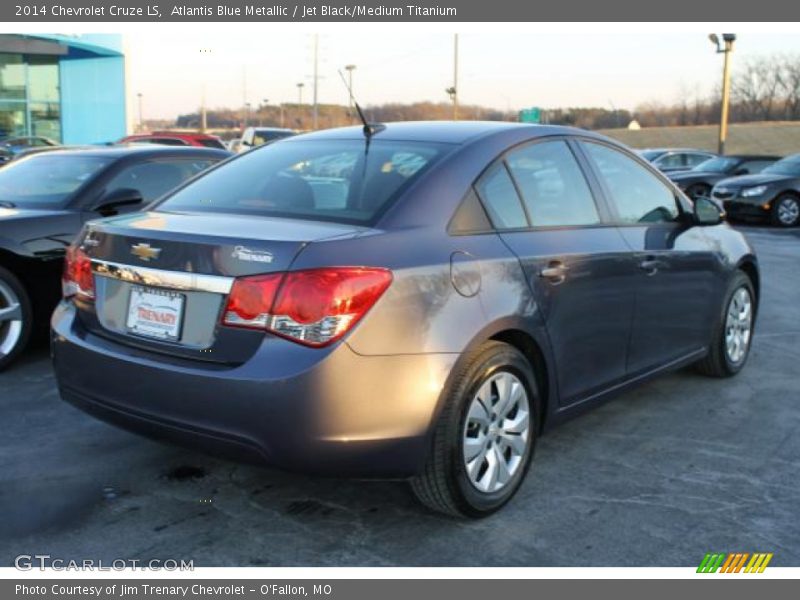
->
[288,121,601,144]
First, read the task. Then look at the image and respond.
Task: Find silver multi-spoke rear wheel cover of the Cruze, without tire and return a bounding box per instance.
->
[463,371,531,494]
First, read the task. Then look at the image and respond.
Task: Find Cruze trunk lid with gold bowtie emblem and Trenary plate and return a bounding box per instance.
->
[72,212,364,364]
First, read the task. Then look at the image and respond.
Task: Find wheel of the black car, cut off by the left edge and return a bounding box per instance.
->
[0,267,33,371]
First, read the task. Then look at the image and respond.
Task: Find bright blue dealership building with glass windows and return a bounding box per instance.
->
[0,34,128,144]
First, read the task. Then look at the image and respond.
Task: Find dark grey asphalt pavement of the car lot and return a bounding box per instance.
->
[0,227,800,566]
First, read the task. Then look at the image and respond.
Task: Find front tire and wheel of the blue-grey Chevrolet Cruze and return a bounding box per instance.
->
[697,271,758,377]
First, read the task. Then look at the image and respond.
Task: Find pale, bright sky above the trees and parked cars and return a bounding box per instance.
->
[125,31,800,119]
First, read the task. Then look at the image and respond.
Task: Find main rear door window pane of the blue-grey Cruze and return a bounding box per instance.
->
[506,141,600,227]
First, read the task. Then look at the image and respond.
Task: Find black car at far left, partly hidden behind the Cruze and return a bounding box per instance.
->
[0,146,230,369]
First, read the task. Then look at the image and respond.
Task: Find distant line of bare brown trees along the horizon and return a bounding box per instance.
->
[162,55,800,130]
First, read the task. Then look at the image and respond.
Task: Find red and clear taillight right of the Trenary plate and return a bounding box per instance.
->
[223,267,392,346]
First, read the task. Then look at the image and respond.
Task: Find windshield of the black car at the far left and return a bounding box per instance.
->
[0,154,112,208]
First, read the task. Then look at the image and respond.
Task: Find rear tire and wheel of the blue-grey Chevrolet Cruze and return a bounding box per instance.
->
[411,341,540,518]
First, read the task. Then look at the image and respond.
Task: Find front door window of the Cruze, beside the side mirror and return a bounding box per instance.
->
[582,142,679,223]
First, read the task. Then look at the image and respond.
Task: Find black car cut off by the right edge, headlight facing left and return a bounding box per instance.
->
[712,154,800,227]
